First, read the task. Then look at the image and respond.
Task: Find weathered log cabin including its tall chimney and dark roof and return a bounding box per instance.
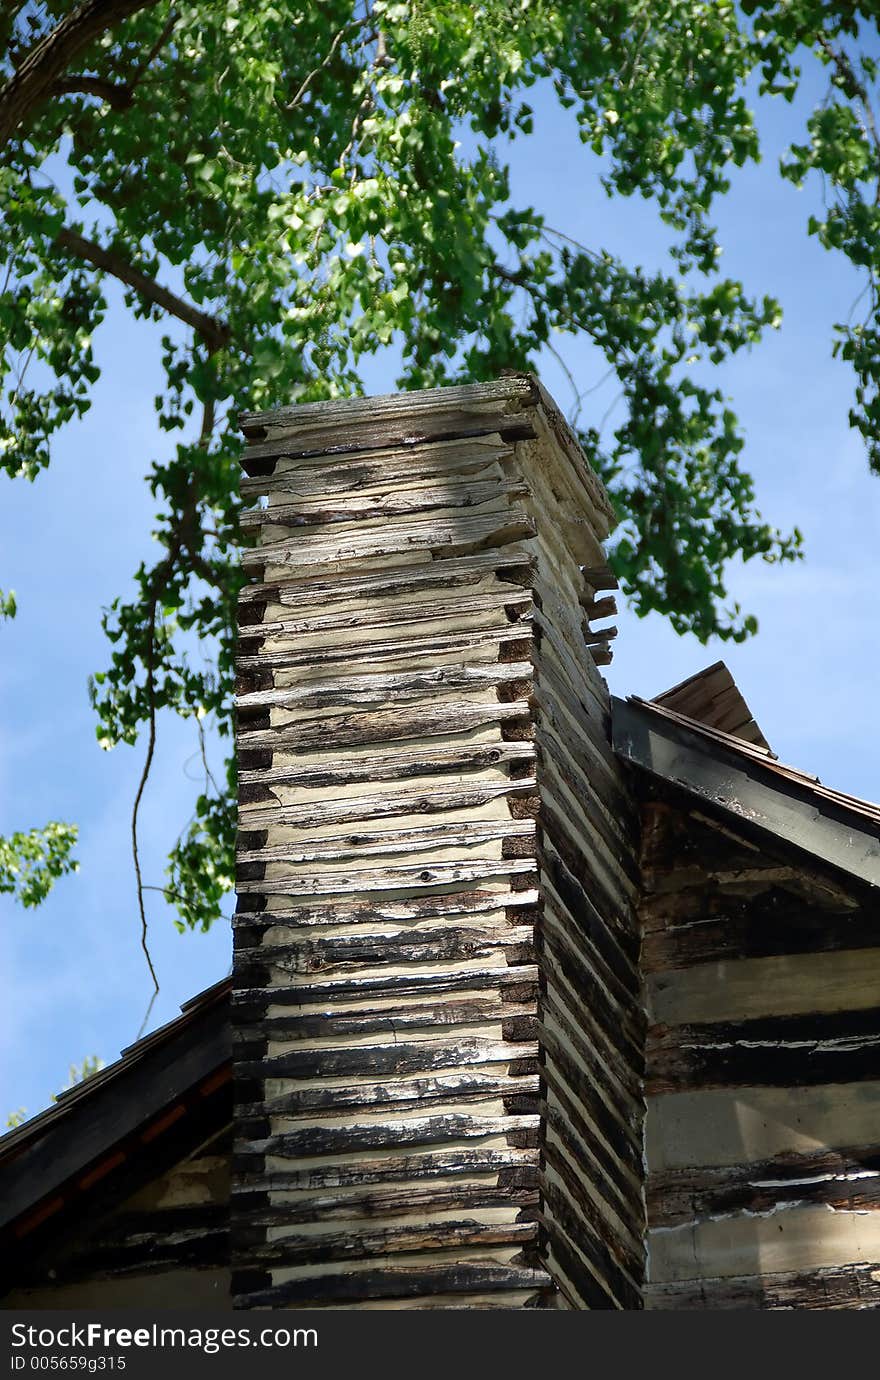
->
[0,375,880,1310]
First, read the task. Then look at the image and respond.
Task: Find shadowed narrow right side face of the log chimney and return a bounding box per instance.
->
[520,427,646,1310]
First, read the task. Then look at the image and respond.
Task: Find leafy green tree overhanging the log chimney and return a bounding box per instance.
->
[0,0,880,956]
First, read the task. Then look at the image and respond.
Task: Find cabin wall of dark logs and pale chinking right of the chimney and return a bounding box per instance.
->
[641,800,880,1310]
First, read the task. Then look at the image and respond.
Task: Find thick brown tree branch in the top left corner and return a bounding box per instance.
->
[0,0,159,149]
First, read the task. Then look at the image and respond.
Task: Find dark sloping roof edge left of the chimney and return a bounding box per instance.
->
[0,978,232,1239]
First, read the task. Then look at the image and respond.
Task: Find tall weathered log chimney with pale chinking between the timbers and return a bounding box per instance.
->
[233,375,644,1308]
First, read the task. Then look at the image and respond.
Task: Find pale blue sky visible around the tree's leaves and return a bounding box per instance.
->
[0,62,880,1126]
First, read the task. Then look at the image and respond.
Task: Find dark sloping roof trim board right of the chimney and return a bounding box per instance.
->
[611,697,880,886]
